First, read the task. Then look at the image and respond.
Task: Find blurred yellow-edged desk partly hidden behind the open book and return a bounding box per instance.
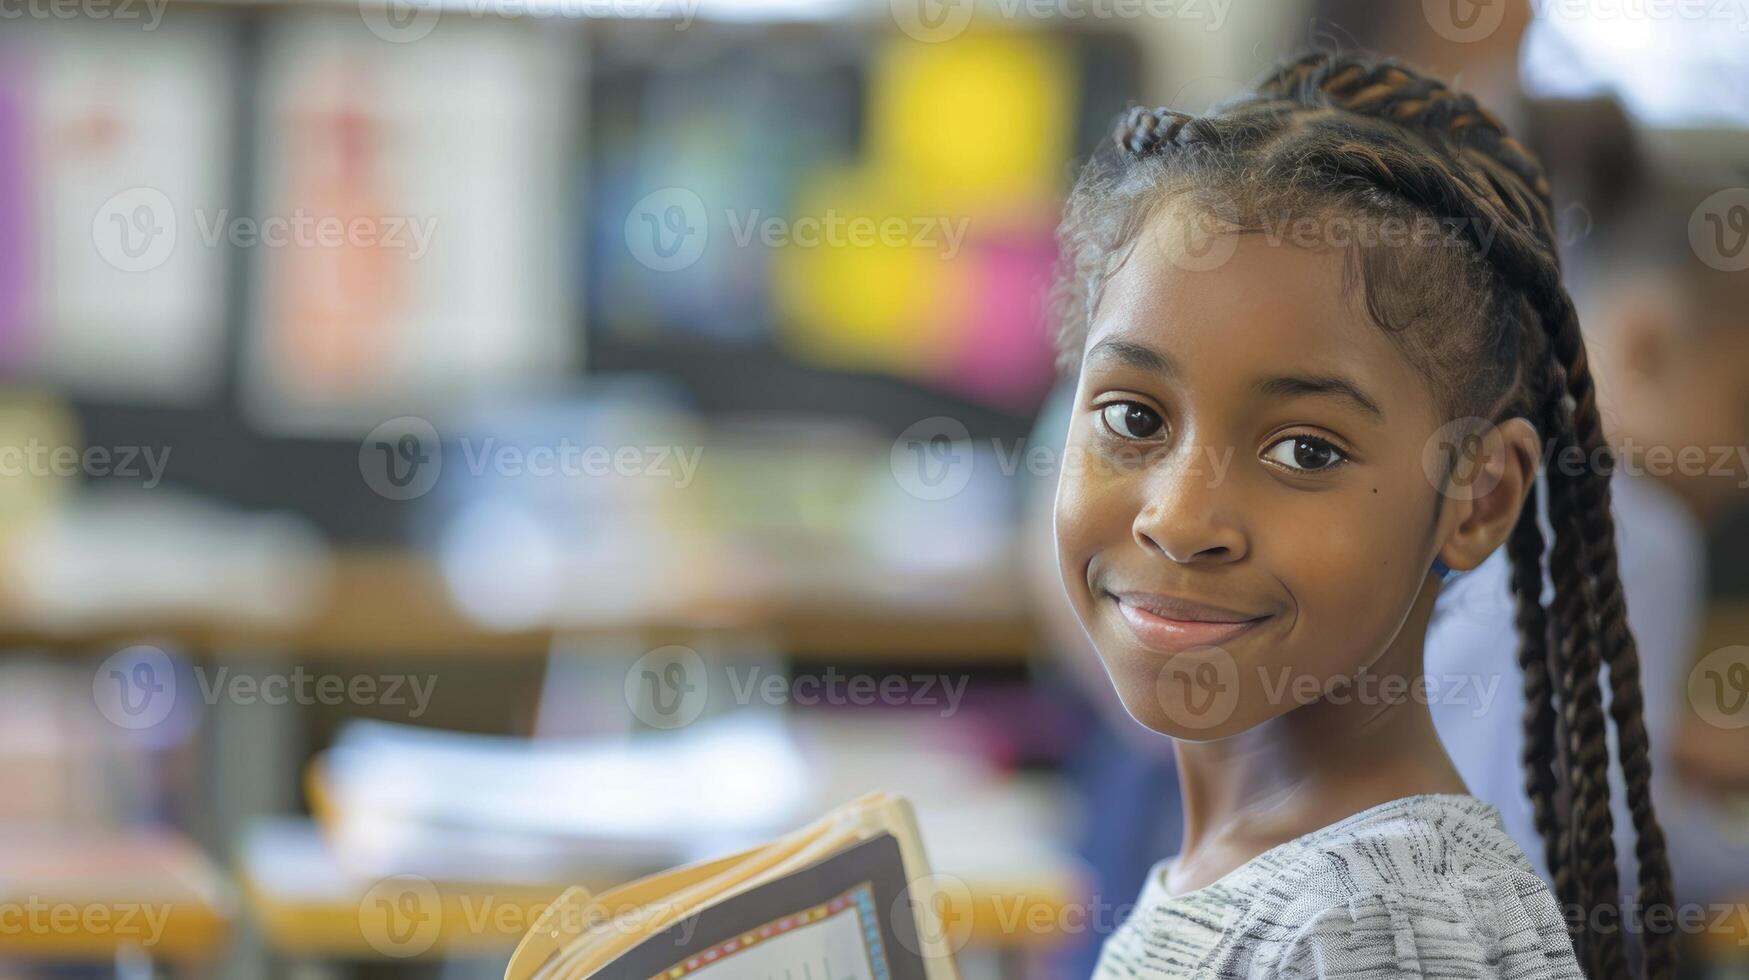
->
[238,817,1083,959]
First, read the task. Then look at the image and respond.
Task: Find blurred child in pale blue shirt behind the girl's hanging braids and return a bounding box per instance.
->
[1427,168,1749,903]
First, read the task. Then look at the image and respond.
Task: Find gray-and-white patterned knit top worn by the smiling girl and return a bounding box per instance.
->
[1093,793,1585,980]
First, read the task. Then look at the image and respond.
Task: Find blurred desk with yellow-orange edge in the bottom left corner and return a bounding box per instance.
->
[0,831,233,963]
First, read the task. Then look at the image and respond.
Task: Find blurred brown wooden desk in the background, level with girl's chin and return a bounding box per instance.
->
[0,551,1032,662]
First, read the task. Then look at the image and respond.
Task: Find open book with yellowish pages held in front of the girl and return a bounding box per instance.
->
[504,793,958,980]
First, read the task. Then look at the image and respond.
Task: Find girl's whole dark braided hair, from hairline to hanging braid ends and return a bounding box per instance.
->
[1056,53,1676,980]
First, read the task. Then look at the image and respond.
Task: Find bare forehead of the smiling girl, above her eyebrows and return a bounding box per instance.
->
[1088,210,1432,415]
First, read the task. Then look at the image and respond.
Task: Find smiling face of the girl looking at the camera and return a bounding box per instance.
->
[1056,214,1441,740]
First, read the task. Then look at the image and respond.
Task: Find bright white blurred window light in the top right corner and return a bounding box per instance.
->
[1522,0,1749,130]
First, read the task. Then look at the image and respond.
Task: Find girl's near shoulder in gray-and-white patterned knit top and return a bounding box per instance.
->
[1252,795,1583,980]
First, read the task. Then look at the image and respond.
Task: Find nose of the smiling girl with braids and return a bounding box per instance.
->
[1130,450,1247,565]
